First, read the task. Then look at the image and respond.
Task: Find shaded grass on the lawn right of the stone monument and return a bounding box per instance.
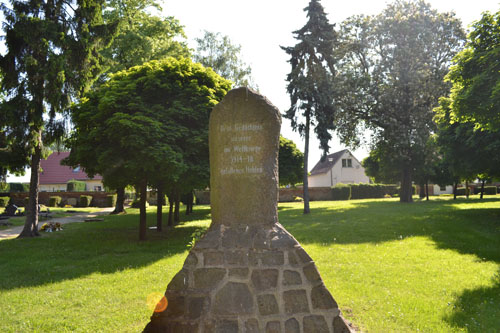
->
[279,199,500,332]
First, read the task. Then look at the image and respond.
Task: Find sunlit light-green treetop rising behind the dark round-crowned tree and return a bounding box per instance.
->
[101,0,190,77]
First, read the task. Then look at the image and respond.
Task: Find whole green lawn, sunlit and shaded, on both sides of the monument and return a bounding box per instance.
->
[0,196,500,332]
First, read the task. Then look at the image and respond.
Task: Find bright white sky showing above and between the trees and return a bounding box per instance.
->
[4,0,500,181]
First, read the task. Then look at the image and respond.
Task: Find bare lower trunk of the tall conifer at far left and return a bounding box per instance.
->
[18,141,42,238]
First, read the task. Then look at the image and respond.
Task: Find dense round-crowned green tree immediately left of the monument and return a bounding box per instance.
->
[66,58,230,240]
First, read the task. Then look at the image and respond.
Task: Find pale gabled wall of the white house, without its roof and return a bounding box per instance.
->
[308,151,370,187]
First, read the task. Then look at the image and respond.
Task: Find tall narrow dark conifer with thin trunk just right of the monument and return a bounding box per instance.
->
[282,0,337,214]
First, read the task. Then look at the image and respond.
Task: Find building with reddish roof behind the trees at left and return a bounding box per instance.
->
[39,152,104,192]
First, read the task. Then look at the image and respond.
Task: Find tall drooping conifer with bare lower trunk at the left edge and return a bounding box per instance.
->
[0,0,114,237]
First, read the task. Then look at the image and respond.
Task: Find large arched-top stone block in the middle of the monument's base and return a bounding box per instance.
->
[214,282,254,315]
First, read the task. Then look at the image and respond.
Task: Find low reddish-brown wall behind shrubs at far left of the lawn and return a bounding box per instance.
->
[9,192,113,207]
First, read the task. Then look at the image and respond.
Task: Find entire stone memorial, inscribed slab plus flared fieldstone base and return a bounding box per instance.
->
[145,88,351,333]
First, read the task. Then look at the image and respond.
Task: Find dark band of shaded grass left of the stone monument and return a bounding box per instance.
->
[0,208,210,290]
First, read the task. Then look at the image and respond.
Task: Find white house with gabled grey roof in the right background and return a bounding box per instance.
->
[308,149,370,187]
